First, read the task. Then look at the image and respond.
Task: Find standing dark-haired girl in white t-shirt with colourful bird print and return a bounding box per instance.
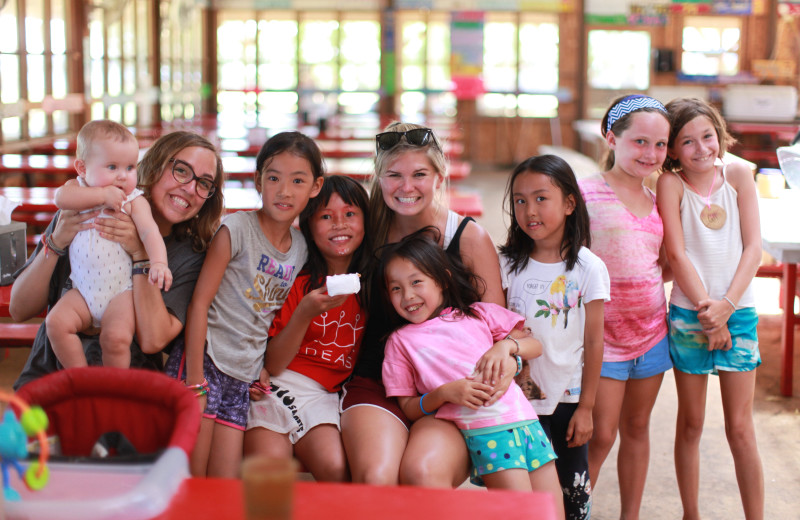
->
[500,155,609,519]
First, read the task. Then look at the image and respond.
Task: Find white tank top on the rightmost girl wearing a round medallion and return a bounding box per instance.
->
[670,166,755,309]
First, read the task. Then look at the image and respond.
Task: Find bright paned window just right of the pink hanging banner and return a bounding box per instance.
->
[477,13,559,117]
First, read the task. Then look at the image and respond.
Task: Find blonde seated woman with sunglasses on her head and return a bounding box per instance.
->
[341,122,516,487]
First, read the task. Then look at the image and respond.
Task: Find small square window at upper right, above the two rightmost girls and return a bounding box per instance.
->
[681,16,741,76]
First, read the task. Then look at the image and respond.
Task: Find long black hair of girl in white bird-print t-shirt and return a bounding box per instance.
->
[500,155,592,272]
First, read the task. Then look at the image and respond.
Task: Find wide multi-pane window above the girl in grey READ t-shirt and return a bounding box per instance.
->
[217,10,381,128]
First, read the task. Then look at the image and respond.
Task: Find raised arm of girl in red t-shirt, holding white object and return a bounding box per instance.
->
[264,285,349,375]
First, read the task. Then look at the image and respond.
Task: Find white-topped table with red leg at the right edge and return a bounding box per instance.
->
[758,190,800,397]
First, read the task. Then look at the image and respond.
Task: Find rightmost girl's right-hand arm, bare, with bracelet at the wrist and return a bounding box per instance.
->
[698,163,761,329]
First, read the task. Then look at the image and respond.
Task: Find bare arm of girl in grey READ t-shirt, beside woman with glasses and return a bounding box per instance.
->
[185,225,231,385]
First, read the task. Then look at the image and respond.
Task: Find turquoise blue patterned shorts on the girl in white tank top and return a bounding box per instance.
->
[669,305,761,374]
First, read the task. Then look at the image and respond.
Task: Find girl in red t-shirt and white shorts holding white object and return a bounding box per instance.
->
[245,175,371,481]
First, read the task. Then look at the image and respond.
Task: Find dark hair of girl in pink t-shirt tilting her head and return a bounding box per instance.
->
[376,226,482,335]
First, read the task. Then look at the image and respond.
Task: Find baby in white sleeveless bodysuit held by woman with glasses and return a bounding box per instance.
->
[45,120,172,368]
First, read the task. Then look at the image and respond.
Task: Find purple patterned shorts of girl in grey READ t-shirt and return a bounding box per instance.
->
[164,342,250,431]
